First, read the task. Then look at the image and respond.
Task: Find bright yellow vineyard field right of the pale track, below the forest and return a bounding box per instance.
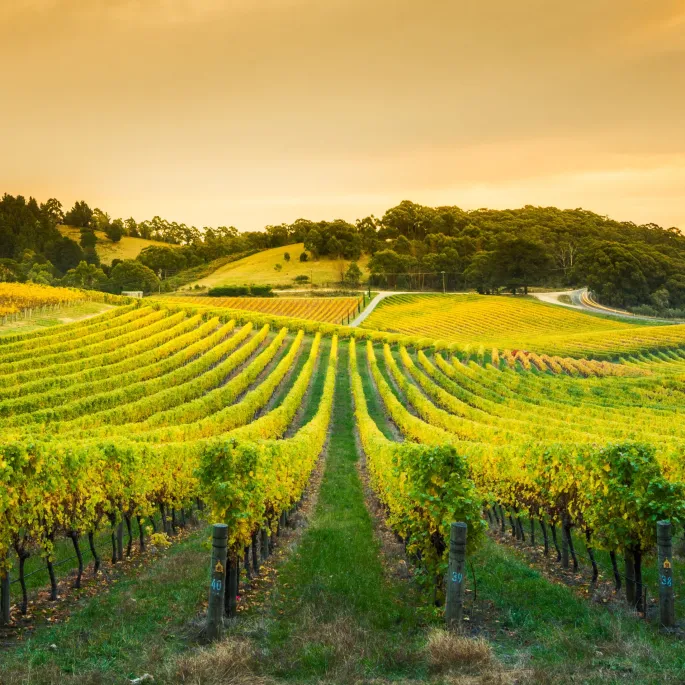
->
[363,295,640,349]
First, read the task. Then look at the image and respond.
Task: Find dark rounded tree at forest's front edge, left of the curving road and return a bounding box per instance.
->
[492,238,550,295]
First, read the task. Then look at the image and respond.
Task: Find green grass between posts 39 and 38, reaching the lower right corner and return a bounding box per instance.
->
[472,540,685,683]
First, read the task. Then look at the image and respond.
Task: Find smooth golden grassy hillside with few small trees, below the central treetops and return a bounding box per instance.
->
[196,243,369,288]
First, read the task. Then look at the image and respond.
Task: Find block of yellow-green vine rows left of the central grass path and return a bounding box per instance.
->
[0,306,337,611]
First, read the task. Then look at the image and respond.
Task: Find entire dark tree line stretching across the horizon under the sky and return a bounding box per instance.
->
[0,195,685,315]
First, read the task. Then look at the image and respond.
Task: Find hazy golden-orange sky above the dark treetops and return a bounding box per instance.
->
[0,0,685,230]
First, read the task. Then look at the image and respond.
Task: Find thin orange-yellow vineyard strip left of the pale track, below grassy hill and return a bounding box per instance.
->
[157,296,359,324]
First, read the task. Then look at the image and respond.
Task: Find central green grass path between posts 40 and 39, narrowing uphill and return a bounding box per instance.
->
[254,344,425,683]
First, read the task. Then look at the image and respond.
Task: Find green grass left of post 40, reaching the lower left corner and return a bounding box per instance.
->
[0,527,209,685]
